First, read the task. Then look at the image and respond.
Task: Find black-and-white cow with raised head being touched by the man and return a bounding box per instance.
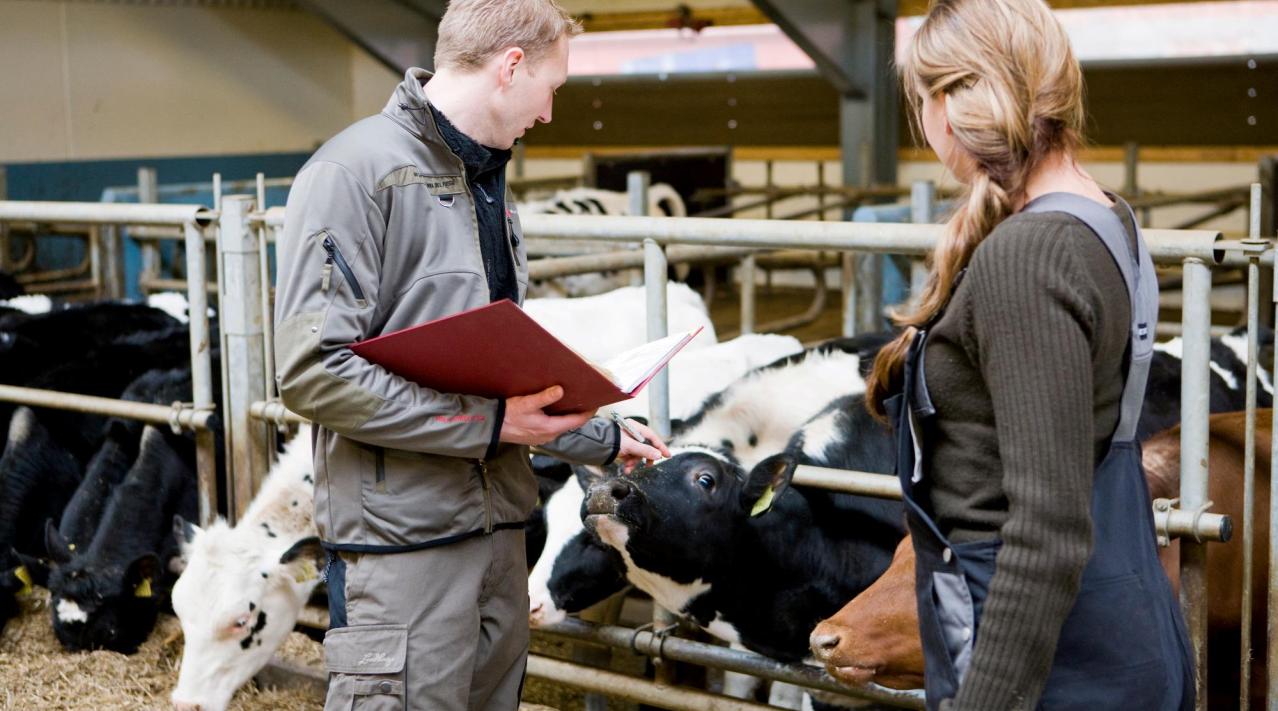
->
[584,395,905,661]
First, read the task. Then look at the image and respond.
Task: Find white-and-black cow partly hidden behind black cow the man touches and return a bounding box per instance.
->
[529,335,888,627]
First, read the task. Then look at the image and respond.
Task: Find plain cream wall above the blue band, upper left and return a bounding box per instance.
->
[0,0,365,162]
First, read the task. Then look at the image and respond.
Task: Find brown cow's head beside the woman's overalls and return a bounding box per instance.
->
[810,536,923,689]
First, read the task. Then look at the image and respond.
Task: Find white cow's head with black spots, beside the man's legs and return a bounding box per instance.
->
[171,518,325,711]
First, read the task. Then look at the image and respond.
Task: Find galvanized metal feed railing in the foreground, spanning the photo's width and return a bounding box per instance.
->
[0,171,1278,708]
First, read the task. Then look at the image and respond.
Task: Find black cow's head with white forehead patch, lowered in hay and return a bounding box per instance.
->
[45,522,161,655]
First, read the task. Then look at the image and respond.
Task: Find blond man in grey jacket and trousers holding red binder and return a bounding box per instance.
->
[275,0,668,711]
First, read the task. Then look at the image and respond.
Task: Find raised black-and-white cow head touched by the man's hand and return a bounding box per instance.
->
[583,448,801,611]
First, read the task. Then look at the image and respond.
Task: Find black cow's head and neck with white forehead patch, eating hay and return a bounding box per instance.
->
[45,426,198,655]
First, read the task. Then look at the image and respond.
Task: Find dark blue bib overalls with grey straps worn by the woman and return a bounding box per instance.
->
[886,193,1194,711]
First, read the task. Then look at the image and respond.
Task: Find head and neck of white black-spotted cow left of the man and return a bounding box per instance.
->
[173,427,323,711]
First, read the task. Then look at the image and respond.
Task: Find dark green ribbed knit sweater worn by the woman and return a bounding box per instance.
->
[923,200,1134,711]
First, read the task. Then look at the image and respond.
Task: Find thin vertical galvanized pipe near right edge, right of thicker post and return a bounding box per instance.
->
[1238,183,1265,711]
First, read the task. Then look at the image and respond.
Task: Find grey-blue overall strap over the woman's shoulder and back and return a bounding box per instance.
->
[1022,193,1158,442]
